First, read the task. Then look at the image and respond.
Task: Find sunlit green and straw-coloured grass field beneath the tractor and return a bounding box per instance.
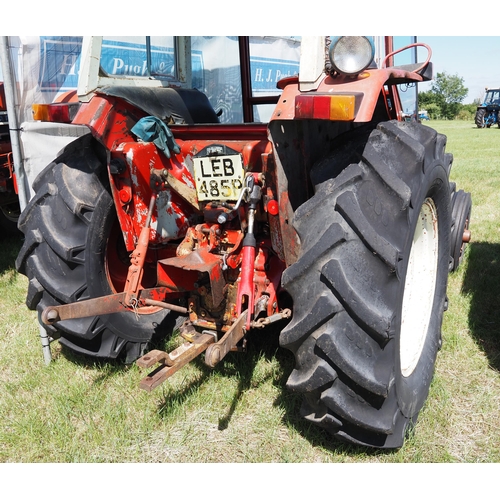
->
[0,121,500,463]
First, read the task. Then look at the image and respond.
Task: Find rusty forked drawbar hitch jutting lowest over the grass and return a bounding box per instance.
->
[136,333,215,392]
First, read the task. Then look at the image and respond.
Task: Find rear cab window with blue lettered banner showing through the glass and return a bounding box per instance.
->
[74,36,301,123]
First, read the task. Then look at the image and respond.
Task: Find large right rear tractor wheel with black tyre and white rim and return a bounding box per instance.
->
[280,122,452,449]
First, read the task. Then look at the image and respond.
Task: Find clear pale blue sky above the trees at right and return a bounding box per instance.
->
[417,36,500,104]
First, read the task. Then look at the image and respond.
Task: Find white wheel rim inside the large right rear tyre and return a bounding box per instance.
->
[399,198,439,377]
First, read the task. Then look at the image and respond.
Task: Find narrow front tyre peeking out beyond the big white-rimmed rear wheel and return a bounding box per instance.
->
[450,189,472,272]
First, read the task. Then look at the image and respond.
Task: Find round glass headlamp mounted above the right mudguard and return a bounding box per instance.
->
[329,36,375,75]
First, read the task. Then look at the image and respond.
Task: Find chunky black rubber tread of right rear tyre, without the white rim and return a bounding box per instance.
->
[280,121,452,448]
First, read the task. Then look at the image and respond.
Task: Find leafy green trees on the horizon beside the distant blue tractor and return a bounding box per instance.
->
[418,72,480,120]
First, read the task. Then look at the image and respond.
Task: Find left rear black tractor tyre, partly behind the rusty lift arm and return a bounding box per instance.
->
[16,135,175,363]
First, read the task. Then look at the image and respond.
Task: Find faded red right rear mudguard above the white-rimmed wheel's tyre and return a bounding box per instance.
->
[269,67,431,266]
